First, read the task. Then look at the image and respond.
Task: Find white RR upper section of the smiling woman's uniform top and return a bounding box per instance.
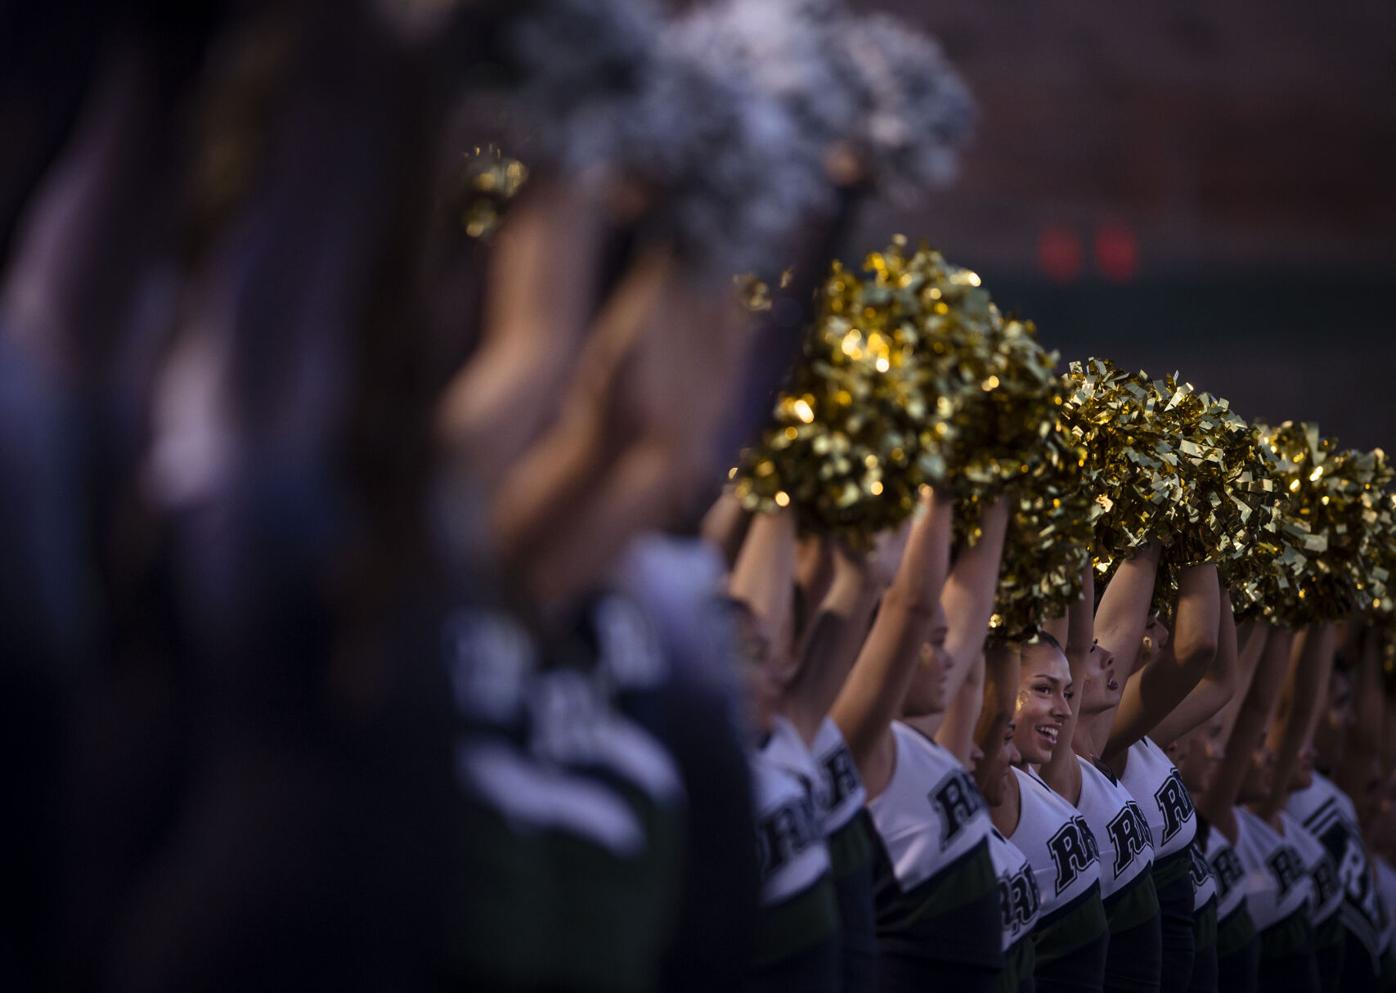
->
[1008,767,1101,923]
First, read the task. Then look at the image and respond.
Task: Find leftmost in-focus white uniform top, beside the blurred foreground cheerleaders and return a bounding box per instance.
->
[751,718,829,906]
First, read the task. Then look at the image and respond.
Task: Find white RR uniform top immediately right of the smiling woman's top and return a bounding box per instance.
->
[1076,756,1159,933]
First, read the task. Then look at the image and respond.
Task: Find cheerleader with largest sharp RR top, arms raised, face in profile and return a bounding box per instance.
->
[832,493,1008,993]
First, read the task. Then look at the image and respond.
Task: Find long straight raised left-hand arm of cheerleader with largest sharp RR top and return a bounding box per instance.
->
[831,489,953,779]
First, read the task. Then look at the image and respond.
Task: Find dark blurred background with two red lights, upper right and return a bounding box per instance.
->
[856,0,1396,450]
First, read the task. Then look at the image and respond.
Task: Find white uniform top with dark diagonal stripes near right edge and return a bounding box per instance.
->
[1284,772,1388,969]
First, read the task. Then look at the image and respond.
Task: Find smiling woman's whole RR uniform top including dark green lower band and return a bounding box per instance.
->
[1009,767,1108,961]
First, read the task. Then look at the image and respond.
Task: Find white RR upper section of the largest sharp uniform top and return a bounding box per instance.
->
[868,721,993,890]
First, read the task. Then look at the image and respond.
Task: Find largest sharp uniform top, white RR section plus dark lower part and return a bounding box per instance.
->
[868,722,1004,990]
